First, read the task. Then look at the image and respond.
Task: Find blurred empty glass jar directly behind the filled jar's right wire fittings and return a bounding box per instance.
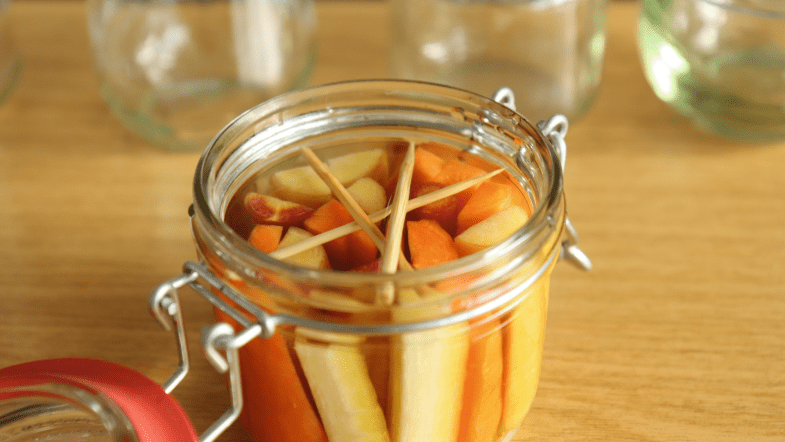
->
[391,0,606,122]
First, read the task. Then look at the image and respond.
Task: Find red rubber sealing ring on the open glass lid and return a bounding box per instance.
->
[0,359,199,442]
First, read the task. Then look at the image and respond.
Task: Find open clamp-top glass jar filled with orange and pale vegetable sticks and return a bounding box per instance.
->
[152,81,590,442]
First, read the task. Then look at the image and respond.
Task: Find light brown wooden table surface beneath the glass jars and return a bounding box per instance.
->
[0,1,785,442]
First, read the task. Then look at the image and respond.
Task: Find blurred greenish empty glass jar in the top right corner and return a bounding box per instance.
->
[638,0,785,141]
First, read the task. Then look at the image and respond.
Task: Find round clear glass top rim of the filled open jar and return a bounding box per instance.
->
[193,80,563,300]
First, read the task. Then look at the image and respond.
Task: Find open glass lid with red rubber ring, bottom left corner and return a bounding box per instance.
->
[0,358,199,442]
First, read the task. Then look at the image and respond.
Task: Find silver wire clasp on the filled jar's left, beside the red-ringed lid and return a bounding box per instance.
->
[148,262,264,442]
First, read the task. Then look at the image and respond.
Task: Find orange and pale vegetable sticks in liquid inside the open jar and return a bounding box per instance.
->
[216,137,550,442]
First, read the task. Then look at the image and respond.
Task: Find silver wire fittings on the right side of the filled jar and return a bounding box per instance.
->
[492,87,592,270]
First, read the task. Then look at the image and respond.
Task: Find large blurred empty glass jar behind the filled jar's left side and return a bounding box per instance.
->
[87,0,316,150]
